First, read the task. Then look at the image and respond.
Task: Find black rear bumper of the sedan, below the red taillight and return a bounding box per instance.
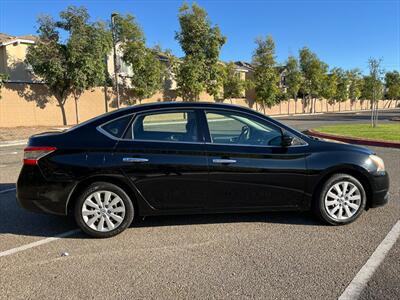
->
[17,165,75,215]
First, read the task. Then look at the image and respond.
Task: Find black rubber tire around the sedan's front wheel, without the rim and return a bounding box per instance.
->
[313,174,367,225]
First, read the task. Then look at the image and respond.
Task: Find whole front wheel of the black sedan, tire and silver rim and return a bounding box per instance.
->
[314,174,367,225]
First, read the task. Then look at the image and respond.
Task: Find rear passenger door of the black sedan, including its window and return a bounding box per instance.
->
[113,110,208,211]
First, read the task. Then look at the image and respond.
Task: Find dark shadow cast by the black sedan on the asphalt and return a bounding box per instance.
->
[0,183,322,238]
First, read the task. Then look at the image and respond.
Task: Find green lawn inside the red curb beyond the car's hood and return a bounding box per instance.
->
[315,123,400,142]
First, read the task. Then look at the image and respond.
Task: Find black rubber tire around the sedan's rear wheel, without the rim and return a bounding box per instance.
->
[74,182,134,238]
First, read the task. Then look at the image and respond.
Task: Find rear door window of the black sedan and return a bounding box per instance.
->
[132,111,199,142]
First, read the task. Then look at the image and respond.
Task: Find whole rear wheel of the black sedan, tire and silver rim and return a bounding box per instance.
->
[74,182,134,238]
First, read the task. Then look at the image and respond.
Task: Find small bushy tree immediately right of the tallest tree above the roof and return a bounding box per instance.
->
[223,62,245,101]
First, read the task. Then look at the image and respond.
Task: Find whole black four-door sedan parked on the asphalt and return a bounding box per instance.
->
[17,102,389,237]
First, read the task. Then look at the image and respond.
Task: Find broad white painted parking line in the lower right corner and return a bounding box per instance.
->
[339,221,400,300]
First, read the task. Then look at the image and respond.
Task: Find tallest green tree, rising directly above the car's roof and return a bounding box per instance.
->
[175,3,226,101]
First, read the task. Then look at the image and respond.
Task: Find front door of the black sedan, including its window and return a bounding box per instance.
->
[202,110,307,210]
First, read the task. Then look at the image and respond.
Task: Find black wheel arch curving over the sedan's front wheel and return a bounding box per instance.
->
[312,165,372,210]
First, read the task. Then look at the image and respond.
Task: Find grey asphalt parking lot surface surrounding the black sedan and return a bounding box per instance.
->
[0,113,400,299]
